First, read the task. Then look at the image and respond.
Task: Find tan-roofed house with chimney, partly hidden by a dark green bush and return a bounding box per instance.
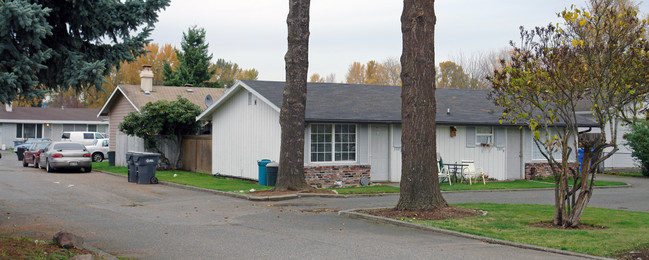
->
[95,66,224,166]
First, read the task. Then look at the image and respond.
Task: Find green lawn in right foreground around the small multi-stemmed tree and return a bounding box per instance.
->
[407,203,649,257]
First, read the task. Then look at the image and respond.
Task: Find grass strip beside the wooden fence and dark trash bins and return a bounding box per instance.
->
[92,161,273,193]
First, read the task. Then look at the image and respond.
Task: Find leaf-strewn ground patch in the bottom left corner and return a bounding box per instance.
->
[0,235,100,259]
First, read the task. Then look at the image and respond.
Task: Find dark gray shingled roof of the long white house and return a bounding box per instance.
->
[242,80,596,126]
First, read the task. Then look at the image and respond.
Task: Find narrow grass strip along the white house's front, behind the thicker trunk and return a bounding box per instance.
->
[332,180,626,194]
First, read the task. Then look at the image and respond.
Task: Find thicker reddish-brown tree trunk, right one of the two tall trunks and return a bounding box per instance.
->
[395,0,448,210]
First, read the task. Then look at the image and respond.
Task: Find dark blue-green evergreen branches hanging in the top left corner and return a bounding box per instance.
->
[0,0,170,103]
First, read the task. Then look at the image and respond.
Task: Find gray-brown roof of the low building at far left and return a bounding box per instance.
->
[0,106,108,122]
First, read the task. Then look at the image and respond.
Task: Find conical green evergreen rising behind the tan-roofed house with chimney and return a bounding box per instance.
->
[162,26,216,87]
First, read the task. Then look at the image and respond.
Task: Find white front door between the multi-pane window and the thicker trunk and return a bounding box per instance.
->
[370,125,390,182]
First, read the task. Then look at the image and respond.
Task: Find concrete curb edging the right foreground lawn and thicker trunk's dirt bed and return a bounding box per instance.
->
[338,208,612,259]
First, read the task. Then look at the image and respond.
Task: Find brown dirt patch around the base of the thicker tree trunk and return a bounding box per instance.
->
[359,206,483,220]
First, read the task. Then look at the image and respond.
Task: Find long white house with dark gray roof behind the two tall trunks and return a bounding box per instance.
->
[198,81,593,187]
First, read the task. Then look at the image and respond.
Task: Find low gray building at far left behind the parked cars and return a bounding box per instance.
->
[0,105,108,148]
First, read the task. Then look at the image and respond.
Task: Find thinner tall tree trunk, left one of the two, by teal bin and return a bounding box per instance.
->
[275,0,310,191]
